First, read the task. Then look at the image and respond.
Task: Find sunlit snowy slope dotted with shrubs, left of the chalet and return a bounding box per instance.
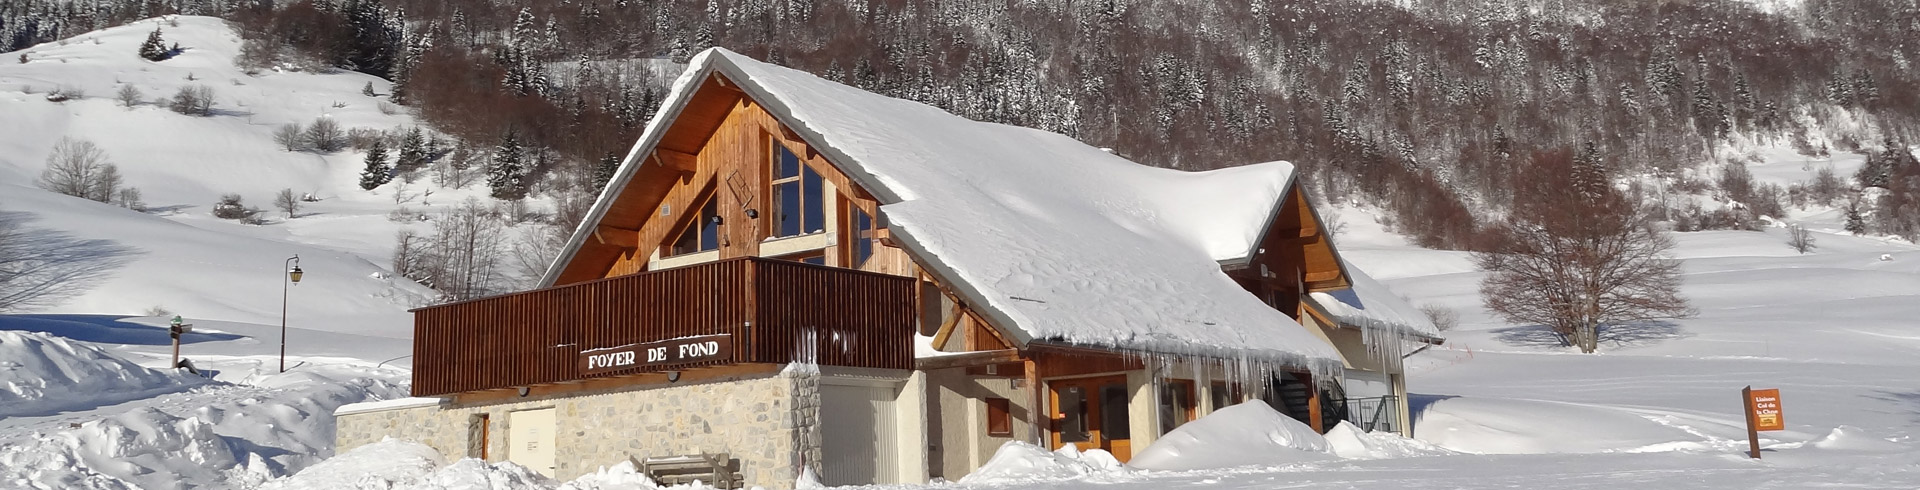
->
[0,17,484,330]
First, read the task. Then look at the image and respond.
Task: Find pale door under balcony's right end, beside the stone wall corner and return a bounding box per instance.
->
[818,384,900,486]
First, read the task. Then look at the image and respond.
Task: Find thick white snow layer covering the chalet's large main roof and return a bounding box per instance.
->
[545,48,1338,363]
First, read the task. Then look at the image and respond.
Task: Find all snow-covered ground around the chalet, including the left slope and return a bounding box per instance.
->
[0,17,1920,490]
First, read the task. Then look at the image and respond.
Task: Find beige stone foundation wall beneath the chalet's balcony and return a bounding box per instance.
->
[334,369,820,488]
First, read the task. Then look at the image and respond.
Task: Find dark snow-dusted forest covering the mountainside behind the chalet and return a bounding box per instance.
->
[11,0,1920,248]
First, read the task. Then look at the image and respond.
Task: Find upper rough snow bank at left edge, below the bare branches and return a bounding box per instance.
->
[0,331,207,419]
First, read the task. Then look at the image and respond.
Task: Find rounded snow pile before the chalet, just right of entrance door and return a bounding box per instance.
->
[1127,402,1332,471]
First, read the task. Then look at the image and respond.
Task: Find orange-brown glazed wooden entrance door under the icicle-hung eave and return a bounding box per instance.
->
[1046,377,1133,463]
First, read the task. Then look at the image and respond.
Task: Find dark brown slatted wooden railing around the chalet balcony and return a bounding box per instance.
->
[413,257,916,396]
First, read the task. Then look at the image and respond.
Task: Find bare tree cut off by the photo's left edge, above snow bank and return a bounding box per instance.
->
[0,211,134,311]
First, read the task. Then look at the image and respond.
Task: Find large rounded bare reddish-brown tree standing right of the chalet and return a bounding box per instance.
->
[1473,150,1693,352]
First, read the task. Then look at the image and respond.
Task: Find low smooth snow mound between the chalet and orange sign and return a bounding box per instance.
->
[1413,398,1699,453]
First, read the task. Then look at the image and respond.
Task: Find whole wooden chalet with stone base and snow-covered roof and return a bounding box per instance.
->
[338,48,1434,488]
